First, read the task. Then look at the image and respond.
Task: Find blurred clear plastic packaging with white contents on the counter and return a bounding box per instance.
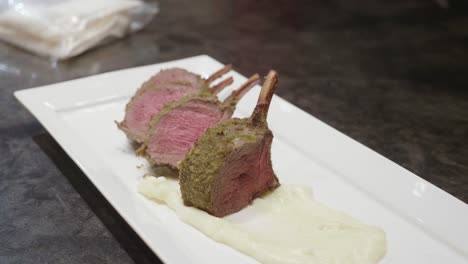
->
[0,0,158,60]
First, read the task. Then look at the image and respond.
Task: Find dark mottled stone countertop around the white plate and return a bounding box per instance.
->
[0,0,468,264]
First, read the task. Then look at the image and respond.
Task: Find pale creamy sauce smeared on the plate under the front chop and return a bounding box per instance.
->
[138,177,386,264]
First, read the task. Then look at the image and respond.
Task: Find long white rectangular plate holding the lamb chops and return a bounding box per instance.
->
[15,55,468,264]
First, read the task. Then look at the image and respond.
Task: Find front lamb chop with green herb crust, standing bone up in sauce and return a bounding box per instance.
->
[179,71,279,217]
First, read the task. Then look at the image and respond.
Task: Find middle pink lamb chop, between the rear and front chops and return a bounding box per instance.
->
[137,74,259,171]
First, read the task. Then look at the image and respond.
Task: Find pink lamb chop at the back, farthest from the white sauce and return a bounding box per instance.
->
[117,65,233,143]
